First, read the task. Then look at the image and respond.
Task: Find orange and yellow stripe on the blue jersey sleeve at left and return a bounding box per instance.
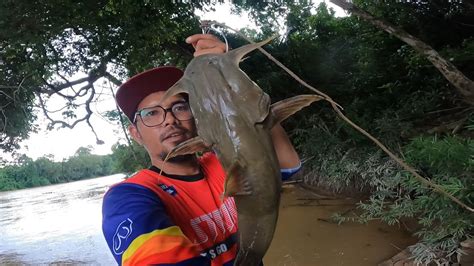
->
[122,226,199,265]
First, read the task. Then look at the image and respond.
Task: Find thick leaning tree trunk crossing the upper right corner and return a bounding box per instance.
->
[330,0,474,105]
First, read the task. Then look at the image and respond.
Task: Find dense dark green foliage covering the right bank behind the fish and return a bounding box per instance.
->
[235,1,474,263]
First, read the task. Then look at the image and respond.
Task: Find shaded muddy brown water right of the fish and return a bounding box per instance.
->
[264,186,416,266]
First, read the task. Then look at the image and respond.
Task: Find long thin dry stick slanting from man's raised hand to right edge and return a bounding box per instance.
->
[215,22,474,212]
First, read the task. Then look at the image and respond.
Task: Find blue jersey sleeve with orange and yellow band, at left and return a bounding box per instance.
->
[102,183,209,266]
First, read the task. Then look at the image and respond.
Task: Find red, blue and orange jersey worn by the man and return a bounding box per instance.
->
[102,153,298,266]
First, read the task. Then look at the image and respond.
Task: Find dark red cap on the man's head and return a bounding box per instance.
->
[116,66,183,121]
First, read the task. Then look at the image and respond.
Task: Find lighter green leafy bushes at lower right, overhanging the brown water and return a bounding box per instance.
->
[337,136,474,264]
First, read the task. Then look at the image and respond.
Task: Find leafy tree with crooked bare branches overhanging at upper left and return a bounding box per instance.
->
[0,0,206,151]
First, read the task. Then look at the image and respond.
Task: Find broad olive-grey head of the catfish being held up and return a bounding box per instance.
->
[163,40,276,123]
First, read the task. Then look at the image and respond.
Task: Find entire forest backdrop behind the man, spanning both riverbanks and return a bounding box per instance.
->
[0,0,474,263]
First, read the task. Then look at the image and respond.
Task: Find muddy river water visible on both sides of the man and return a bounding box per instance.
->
[0,175,414,266]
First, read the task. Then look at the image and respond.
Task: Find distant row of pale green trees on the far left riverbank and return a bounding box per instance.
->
[0,147,118,191]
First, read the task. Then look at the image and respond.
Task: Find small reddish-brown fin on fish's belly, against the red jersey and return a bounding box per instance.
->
[224,161,252,197]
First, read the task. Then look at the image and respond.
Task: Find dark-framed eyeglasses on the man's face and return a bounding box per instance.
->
[133,101,193,127]
